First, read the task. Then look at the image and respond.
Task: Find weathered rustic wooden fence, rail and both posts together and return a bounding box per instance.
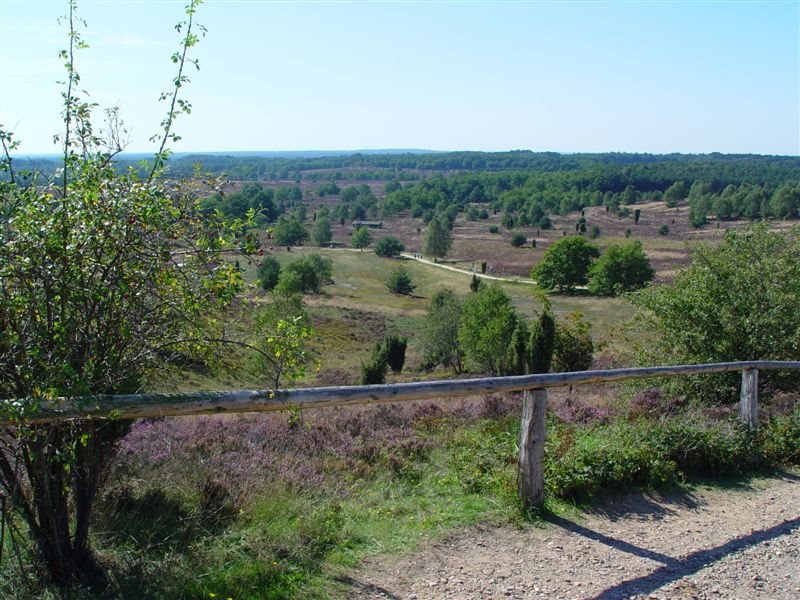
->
[0,361,800,506]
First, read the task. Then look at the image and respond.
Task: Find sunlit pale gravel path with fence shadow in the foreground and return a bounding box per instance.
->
[351,471,800,600]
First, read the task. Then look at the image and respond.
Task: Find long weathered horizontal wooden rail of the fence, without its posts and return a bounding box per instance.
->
[0,361,800,425]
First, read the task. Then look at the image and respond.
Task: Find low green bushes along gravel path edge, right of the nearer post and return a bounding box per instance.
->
[545,410,800,499]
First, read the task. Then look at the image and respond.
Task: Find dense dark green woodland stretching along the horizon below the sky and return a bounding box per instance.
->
[152,152,800,229]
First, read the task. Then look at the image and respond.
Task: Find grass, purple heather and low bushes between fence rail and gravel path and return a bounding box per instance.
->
[0,394,800,600]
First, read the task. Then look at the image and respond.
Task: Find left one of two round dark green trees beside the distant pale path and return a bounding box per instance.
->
[531,236,600,291]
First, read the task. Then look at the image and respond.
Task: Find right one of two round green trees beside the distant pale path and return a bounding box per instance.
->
[589,240,655,296]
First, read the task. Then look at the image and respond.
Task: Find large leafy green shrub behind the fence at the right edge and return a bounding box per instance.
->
[633,224,800,403]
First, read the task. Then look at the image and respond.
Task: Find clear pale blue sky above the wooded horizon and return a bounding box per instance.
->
[0,0,800,155]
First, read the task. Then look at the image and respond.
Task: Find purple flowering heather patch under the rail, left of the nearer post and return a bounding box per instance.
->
[114,395,518,496]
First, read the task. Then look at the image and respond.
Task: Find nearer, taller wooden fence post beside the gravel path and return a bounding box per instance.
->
[517,389,547,508]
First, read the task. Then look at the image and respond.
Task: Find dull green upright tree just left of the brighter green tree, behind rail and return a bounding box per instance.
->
[420,289,462,373]
